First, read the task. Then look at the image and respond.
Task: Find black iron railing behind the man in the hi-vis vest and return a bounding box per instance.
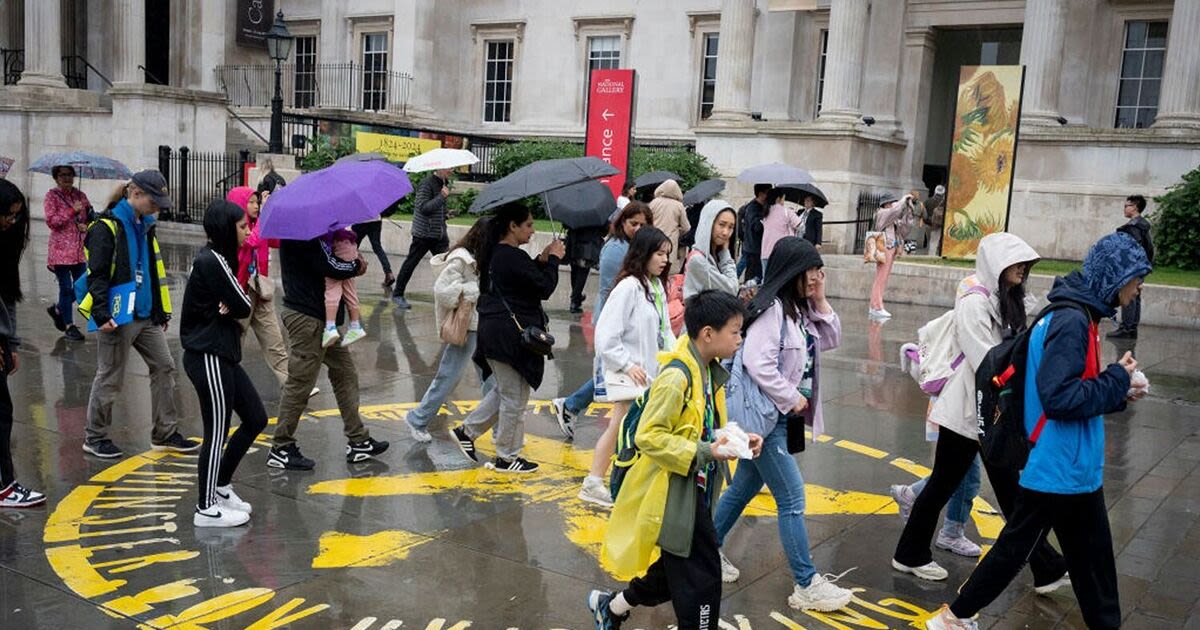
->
[158,145,250,223]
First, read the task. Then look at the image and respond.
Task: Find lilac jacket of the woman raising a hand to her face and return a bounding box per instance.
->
[742,300,841,436]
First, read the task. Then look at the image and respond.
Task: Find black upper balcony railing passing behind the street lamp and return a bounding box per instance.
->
[215,62,413,114]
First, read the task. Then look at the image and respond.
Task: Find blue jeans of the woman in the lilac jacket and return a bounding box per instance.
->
[713,419,817,587]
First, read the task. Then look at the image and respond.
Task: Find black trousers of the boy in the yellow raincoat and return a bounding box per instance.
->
[625,487,721,630]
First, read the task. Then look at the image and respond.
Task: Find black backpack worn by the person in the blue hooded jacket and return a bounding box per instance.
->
[976,301,1099,470]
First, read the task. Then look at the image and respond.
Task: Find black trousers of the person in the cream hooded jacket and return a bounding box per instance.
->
[895,428,1067,586]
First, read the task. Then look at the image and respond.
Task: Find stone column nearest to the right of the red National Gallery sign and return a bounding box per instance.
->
[709,0,755,120]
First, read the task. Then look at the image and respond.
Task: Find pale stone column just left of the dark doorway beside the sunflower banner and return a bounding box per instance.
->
[820,0,870,122]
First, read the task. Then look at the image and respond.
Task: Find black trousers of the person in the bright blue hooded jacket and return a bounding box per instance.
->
[950,488,1121,628]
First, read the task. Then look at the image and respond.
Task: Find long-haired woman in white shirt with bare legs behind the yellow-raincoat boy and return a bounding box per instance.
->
[580,228,674,508]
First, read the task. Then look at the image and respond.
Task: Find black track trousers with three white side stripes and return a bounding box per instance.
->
[184,350,266,510]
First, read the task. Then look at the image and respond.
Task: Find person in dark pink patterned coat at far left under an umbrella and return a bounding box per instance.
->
[42,164,91,341]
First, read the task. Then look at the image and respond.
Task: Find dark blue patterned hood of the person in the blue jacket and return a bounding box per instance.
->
[1048,232,1151,318]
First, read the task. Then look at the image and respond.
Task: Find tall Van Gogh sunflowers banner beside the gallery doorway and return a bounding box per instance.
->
[942,66,1025,258]
